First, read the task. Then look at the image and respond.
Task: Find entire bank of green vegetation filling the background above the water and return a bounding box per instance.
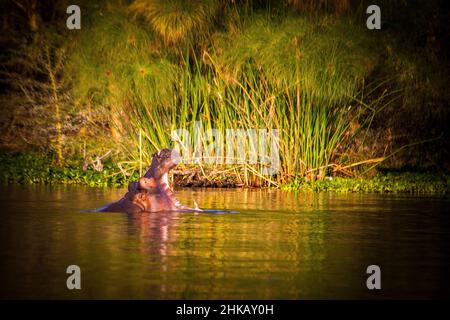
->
[0,0,448,190]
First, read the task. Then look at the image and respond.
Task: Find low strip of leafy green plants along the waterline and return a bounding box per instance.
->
[0,153,450,194]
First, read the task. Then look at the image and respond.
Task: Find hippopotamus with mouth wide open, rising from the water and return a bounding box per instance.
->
[95,149,202,213]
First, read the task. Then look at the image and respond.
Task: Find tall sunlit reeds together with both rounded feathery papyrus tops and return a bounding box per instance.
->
[68,6,384,185]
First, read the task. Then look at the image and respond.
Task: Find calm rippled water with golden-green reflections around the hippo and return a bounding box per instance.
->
[0,186,450,299]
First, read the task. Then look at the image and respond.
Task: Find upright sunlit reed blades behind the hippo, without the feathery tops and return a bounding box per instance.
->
[113,54,376,184]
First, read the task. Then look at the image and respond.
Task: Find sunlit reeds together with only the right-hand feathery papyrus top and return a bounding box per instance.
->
[100,12,382,185]
